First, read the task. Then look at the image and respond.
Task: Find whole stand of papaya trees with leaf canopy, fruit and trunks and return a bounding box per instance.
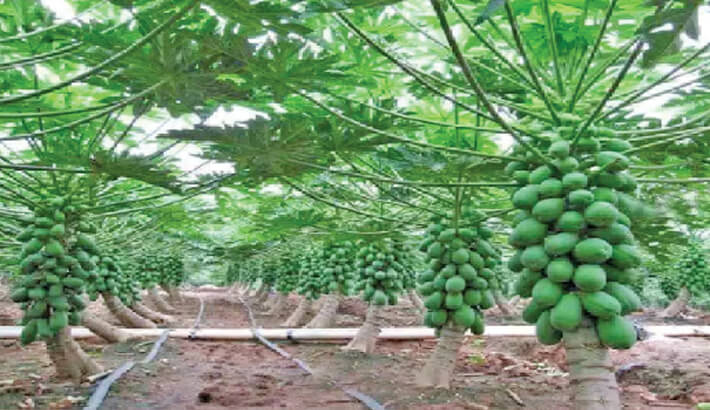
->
[0,0,710,410]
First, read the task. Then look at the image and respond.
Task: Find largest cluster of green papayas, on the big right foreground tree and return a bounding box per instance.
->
[506,129,640,349]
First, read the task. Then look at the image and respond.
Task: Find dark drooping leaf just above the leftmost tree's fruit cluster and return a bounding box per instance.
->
[91,151,179,192]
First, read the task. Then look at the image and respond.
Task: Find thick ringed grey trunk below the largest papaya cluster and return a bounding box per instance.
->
[563,319,621,410]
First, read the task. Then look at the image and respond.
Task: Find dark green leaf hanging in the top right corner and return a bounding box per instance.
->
[639,0,703,68]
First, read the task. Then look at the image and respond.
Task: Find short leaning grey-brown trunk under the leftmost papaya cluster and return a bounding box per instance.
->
[45,326,102,384]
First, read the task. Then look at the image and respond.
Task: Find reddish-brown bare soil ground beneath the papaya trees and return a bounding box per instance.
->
[0,291,710,410]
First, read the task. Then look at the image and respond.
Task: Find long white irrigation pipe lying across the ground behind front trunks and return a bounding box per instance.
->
[0,325,710,340]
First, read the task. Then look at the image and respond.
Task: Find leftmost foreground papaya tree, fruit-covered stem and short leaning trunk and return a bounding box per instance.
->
[11,193,101,383]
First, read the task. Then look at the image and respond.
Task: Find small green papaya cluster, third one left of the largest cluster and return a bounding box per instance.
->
[297,241,356,300]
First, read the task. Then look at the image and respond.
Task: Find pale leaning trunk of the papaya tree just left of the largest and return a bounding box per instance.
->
[415,327,465,389]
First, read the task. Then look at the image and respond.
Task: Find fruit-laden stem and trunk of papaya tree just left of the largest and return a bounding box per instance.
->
[416,206,500,389]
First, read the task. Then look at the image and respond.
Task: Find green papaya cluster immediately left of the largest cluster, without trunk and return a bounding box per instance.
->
[417,208,500,335]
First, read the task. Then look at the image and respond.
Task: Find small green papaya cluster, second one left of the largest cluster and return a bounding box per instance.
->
[355,238,412,306]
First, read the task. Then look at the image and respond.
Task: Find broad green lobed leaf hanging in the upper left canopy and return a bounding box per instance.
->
[84,16,253,116]
